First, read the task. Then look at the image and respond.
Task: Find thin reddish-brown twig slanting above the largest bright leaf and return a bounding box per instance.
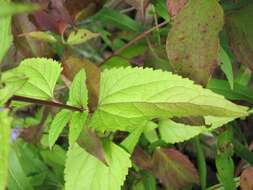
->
[99,21,169,66]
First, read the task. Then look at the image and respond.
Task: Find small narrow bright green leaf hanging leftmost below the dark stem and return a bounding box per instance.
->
[48,110,72,148]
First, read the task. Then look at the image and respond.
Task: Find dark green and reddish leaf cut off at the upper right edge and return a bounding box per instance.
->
[226,4,253,71]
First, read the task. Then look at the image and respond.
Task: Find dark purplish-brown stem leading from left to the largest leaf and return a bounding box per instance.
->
[10,96,84,112]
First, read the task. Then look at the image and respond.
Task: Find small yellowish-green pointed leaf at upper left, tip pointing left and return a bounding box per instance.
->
[20,31,57,43]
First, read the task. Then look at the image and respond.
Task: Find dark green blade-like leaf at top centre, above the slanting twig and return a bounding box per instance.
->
[94,8,143,32]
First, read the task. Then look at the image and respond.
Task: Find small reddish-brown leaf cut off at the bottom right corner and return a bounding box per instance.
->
[240,167,253,190]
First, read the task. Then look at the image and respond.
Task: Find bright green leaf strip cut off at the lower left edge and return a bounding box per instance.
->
[0,110,12,190]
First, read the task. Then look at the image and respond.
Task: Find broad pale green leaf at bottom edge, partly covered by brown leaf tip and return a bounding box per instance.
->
[65,142,131,190]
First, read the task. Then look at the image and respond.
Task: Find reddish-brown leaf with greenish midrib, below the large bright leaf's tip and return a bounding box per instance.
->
[152,148,199,189]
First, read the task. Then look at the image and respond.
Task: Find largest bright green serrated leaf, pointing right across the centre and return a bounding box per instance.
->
[90,67,248,131]
